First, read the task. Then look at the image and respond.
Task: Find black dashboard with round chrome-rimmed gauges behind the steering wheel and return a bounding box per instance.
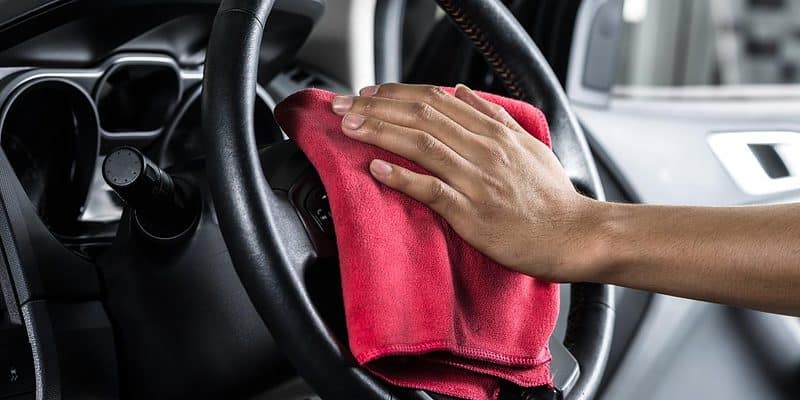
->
[0,0,343,398]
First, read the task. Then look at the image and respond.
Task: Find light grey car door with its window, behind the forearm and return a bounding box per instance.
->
[568,0,800,399]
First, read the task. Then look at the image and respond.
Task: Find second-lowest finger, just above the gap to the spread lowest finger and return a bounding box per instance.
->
[342,113,474,189]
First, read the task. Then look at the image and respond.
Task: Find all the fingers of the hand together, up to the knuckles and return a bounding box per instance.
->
[332,84,543,212]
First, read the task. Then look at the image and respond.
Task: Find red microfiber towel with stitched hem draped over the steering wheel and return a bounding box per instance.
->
[275,89,558,400]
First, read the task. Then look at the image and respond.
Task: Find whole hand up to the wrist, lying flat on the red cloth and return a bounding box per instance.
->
[333,84,597,281]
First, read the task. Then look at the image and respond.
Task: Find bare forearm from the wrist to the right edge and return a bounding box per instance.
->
[584,203,800,315]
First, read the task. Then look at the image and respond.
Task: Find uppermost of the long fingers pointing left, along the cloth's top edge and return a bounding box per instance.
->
[360,83,510,136]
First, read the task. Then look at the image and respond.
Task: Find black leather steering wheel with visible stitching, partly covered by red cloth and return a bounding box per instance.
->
[202,0,614,400]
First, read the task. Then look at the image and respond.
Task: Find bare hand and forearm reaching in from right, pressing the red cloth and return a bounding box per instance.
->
[333,84,800,316]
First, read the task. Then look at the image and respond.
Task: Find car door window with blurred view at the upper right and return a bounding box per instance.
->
[612,0,800,98]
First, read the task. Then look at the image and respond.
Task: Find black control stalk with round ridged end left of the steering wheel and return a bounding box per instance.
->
[103,146,197,238]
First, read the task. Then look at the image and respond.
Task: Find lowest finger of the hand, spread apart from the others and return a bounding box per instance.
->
[369,160,467,221]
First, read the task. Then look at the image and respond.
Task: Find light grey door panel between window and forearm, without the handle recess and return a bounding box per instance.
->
[575,99,800,206]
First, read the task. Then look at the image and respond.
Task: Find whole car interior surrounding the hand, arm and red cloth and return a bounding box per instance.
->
[0,0,800,400]
